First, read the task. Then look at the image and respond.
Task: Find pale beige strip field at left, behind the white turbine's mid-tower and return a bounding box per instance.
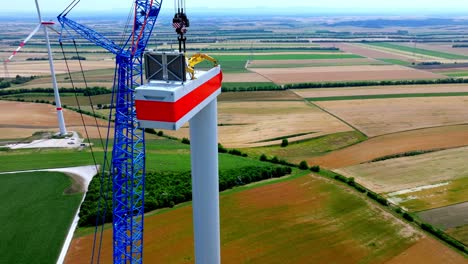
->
[0,60,115,77]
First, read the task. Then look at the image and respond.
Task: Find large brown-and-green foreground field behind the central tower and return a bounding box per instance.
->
[66,176,442,263]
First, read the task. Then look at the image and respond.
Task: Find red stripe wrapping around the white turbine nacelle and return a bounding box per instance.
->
[135,72,223,123]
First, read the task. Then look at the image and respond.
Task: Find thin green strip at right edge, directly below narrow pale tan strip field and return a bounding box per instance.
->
[307,92,468,102]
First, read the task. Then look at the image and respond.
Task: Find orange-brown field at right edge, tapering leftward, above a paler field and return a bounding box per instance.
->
[307,125,468,169]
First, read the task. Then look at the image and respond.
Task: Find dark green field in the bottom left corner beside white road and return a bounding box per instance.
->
[0,172,83,263]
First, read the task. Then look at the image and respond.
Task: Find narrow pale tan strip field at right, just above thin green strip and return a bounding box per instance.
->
[293,84,468,98]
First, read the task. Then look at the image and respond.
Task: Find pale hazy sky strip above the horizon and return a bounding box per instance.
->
[0,0,468,13]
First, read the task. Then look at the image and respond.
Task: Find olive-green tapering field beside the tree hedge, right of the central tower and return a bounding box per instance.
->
[243,131,366,165]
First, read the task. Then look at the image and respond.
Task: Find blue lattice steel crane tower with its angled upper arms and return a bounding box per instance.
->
[58,0,162,263]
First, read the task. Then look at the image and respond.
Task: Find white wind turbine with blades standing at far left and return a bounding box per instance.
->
[4,0,67,136]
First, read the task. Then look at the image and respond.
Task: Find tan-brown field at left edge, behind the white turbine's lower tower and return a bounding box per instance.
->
[0,101,113,139]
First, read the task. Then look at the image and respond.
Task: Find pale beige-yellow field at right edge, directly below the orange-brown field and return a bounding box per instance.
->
[335,147,468,193]
